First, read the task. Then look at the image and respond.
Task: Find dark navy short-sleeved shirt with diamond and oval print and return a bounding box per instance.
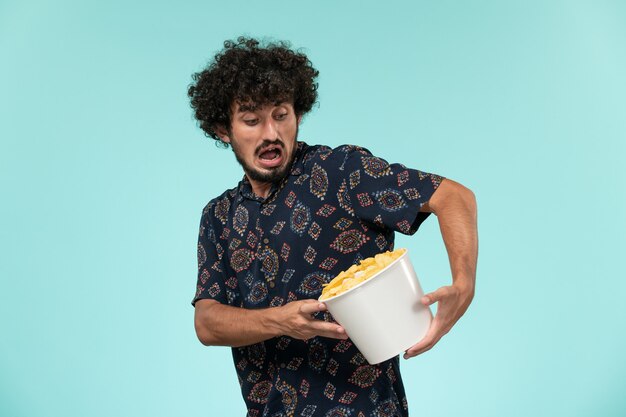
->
[193,142,442,417]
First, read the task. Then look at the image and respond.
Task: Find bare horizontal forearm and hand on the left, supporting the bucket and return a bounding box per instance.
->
[194,299,348,347]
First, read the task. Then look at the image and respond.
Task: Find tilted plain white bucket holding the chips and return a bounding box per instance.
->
[321,251,433,365]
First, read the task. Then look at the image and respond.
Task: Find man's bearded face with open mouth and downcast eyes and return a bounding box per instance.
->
[220,102,300,185]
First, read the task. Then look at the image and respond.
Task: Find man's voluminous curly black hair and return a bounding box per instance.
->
[187,36,319,147]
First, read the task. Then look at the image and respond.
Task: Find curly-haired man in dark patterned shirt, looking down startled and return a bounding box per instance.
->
[188,38,478,417]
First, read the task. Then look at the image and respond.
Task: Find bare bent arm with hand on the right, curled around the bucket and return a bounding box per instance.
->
[404,179,478,359]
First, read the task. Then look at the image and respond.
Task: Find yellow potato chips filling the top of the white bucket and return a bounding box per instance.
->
[320,249,406,300]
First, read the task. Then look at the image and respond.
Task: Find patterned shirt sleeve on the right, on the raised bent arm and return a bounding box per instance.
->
[344,146,443,235]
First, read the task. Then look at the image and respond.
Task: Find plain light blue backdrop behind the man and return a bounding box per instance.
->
[0,0,626,417]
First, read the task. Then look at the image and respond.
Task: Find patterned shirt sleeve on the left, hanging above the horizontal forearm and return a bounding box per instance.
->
[191,205,228,306]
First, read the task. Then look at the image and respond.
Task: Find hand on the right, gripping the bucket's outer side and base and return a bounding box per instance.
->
[404,284,474,359]
